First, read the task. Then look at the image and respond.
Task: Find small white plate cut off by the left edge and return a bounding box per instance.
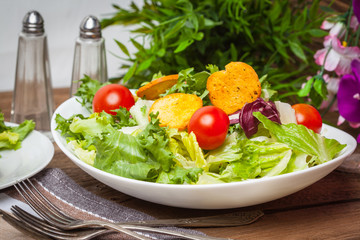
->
[0,123,54,189]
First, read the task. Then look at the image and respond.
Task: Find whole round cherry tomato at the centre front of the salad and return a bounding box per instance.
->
[188,106,230,150]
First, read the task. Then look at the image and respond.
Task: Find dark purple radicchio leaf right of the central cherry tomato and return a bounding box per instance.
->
[239,98,281,138]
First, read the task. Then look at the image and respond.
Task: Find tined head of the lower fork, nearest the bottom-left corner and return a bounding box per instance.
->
[0,209,110,240]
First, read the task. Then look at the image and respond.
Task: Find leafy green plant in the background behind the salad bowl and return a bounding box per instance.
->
[102,0,327,101]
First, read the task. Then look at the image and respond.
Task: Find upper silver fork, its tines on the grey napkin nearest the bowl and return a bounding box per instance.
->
[14,179,231,240]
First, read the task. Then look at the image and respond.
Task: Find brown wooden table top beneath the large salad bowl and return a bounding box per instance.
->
[0,89,360,239]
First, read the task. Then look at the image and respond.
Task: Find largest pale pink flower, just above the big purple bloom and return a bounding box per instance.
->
[314,35,360,76]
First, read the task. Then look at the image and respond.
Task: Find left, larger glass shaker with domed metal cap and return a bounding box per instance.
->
[11,11,54,138]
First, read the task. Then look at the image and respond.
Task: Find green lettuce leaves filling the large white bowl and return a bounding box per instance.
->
[55,86,345,184]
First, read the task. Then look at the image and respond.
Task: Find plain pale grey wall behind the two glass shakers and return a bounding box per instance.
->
[0,0,142,92]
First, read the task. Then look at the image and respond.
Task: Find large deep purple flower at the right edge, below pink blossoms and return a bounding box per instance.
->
[337,59,360,122]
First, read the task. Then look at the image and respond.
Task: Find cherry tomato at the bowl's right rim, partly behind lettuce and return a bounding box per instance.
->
[292,103,322,133]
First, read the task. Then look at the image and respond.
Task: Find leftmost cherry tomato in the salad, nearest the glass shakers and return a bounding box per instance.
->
[93,84,135,115]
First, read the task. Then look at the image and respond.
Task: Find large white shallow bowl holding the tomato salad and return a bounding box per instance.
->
[51,98,356,209]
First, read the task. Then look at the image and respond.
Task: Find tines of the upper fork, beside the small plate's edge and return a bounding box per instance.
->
[14,181,73,224]
